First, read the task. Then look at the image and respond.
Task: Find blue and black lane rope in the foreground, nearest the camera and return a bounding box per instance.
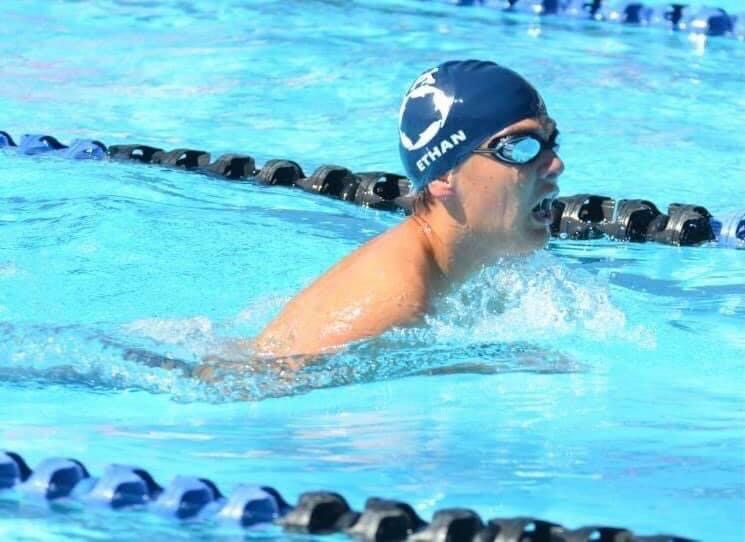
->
[0,451,692,542]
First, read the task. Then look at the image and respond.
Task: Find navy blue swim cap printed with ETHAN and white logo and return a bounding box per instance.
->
[398,60,546,189]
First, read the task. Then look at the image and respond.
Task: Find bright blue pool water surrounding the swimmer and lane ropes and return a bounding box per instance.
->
[0,0,745,541]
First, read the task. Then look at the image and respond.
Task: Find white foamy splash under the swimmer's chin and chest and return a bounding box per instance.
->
[427,253,654,345]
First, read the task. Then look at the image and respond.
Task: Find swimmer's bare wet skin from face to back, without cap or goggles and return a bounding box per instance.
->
[248,117,564,365]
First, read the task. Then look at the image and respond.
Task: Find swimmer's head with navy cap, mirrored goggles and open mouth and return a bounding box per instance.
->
[400,60,564,263]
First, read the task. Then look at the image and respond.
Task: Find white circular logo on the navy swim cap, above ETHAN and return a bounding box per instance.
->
[398,68,454,151]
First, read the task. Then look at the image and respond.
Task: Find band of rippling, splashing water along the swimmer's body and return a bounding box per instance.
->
[0,253,654,401]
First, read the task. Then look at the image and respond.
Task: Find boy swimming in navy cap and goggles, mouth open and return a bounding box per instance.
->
[253,60,564,363]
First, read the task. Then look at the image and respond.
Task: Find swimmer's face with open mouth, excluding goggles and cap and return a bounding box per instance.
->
[453,117,564,256]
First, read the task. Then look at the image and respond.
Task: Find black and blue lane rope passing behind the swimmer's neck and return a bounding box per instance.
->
[0,131,745,249]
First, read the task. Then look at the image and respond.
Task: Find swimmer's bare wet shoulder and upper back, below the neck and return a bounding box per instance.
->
[255,219,436,356]
